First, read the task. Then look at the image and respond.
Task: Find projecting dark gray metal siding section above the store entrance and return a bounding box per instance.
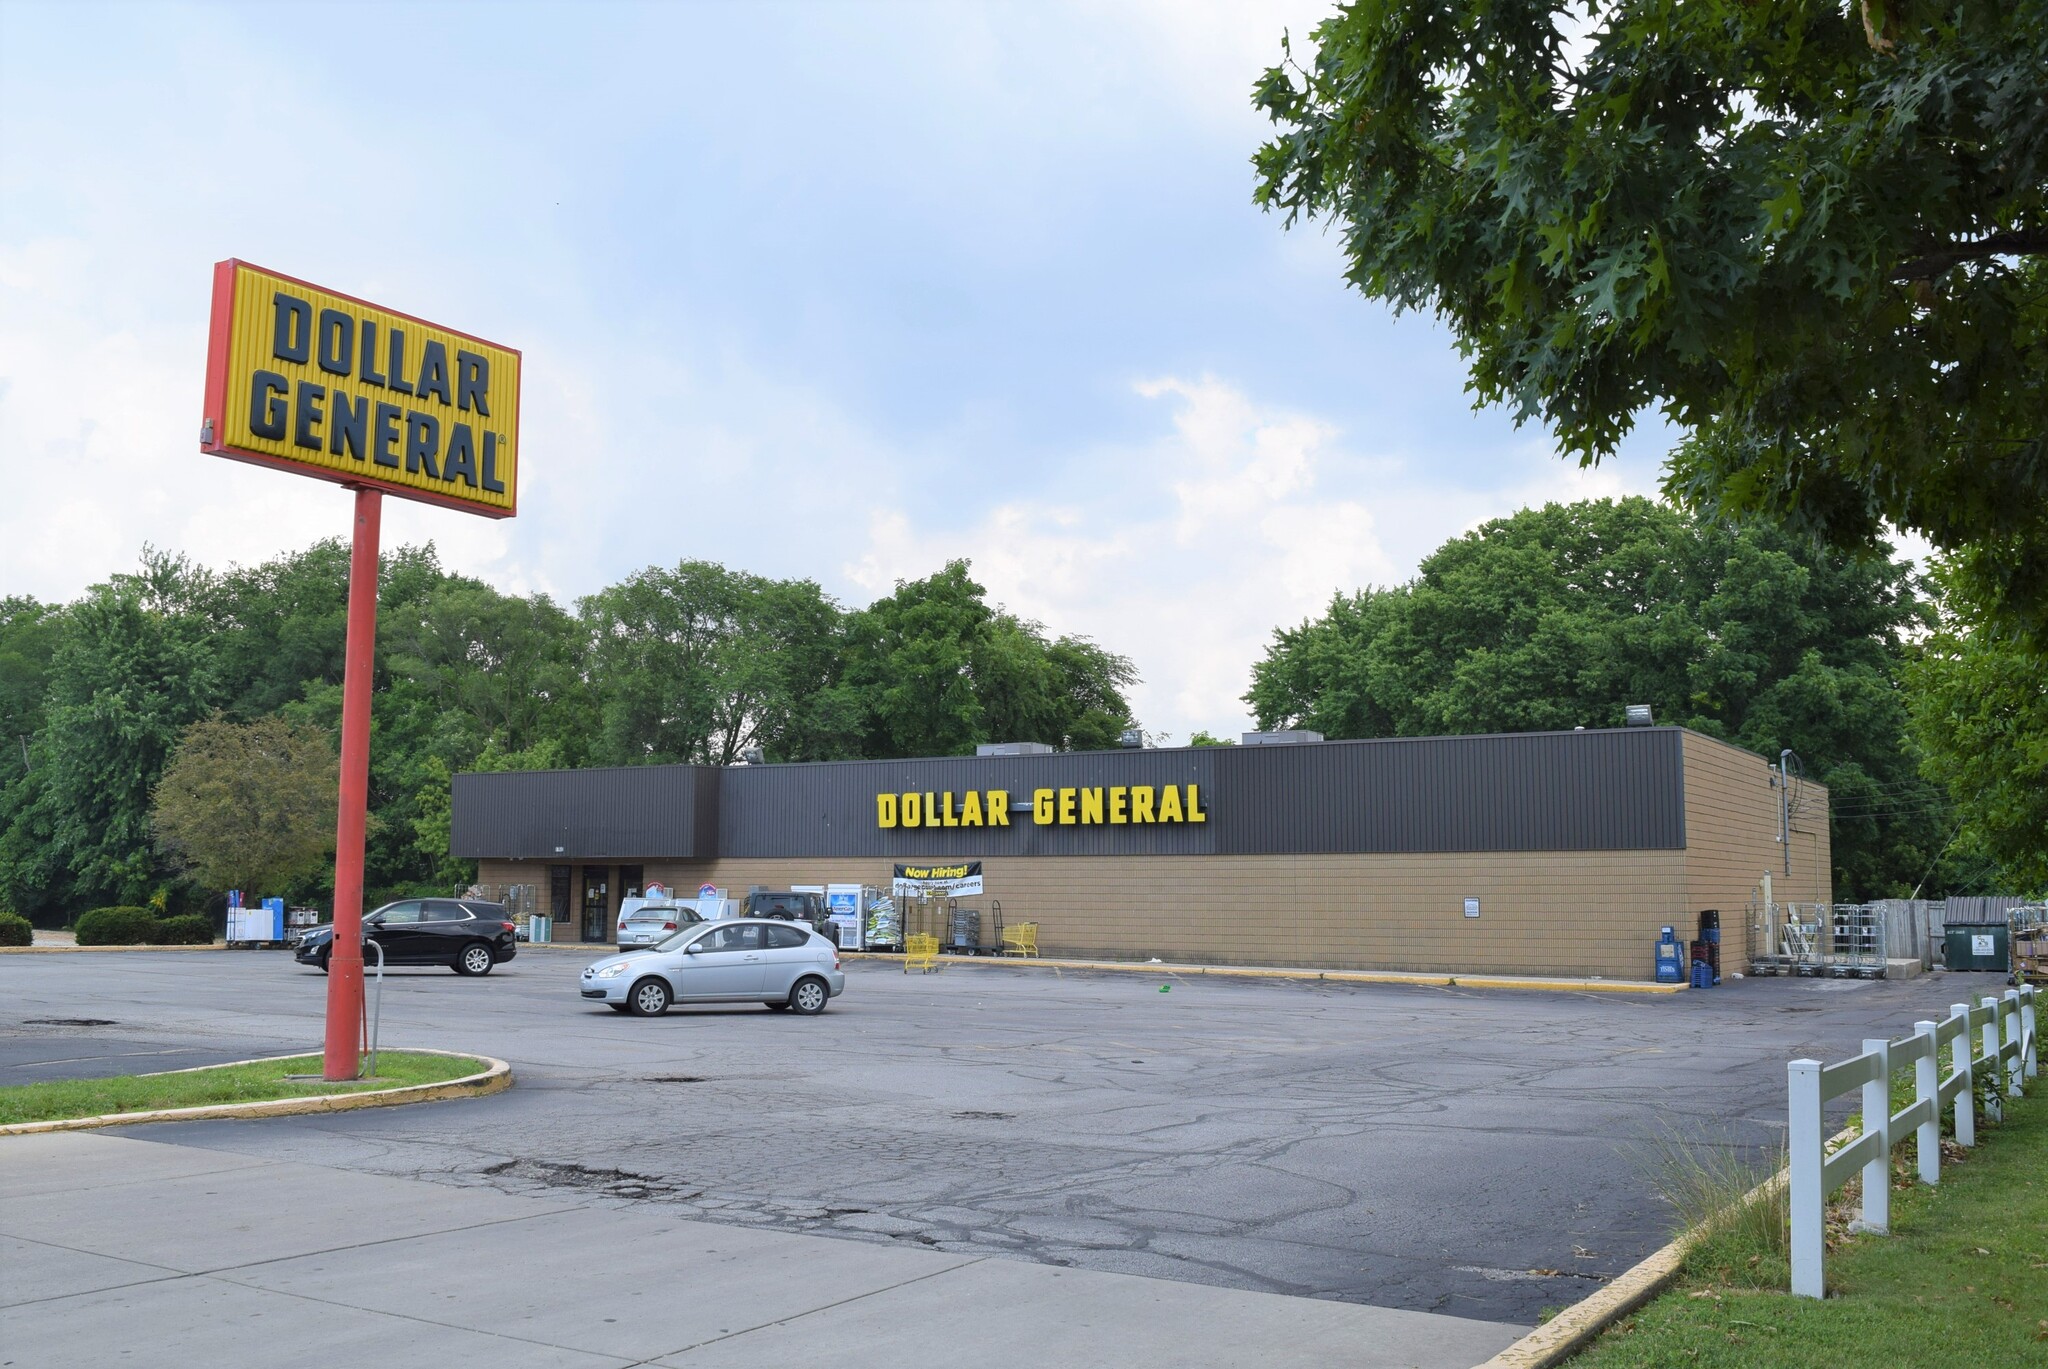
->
[451,764,719,861]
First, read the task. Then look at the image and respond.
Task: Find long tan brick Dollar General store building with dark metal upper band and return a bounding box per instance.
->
[455,728,1833,980]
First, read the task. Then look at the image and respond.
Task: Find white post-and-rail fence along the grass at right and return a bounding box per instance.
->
[1786,986,2040,1297]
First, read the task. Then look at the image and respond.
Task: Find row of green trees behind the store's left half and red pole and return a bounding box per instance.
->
[0,541,1137,920]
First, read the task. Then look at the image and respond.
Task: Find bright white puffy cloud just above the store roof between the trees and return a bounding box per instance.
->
[844,377,1397,738]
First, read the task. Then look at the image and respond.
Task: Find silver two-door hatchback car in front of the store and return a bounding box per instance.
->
[582,918,846,1017]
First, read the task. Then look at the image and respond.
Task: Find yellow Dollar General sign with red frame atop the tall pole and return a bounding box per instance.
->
[199,260,520,518]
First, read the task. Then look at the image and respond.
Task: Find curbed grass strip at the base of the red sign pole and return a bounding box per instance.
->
[0,1051,485,1125]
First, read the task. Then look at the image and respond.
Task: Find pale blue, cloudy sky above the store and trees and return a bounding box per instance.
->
[0,0,1669,740]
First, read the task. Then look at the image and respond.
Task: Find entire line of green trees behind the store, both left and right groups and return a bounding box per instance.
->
[0,498,2023,920]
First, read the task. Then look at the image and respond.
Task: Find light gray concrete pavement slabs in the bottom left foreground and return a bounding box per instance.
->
[0,1133,1524,1369]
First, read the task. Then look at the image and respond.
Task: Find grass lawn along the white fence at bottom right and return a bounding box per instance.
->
[1571,1076,2048,1369]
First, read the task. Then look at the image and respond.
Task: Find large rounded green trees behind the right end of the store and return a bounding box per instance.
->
[1245,498,2048,900]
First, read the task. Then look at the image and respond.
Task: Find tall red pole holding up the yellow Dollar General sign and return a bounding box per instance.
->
[326,488,383,1080]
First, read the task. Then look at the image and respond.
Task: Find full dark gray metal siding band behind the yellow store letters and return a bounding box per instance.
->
[455,728,1686,861]
